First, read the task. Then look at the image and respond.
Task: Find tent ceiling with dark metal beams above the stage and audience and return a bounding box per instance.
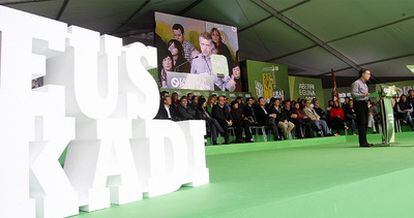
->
[0,0,414,77]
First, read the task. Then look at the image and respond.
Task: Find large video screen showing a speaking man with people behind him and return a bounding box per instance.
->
[154,12,244,92]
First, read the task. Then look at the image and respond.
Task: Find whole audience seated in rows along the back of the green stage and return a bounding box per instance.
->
[156,90,414,144]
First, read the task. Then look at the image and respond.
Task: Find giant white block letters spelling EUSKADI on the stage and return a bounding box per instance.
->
[0,6,209,218]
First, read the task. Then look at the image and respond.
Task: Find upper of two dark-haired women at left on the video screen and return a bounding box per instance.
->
[168,39,191,73]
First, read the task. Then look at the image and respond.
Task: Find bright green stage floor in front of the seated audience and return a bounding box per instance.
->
[77,132,414,218]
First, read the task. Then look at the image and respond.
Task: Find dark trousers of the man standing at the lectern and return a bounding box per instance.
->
[354,101,368,145]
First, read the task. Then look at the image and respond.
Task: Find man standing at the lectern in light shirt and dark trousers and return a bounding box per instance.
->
[351,69,373,147]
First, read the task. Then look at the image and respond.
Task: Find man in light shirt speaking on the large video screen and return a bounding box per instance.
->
[191,32,236,91]
